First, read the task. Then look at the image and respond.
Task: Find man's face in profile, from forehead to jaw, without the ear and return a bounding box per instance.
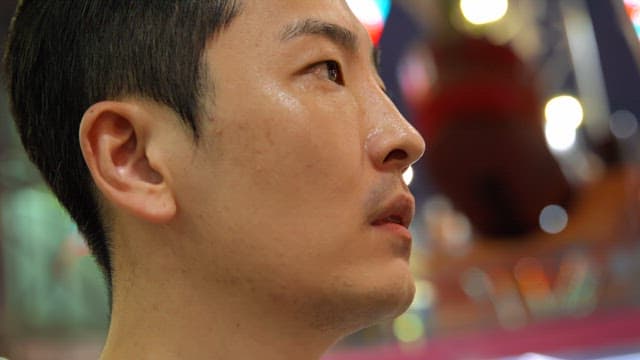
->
[165,0,424,326]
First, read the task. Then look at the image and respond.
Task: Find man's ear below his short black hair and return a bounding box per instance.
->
[79,101,176,223]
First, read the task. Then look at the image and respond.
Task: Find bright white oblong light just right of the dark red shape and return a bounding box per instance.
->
[544,95,584,151]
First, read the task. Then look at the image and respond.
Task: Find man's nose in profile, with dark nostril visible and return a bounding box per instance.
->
[367,96,425,173]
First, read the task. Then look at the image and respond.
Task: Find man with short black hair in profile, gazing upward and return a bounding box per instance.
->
[6,0,424,360]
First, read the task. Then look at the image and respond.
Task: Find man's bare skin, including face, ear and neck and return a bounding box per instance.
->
[80,0,424,360]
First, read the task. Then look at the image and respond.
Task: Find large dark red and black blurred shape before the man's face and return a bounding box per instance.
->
[415,35,571,237]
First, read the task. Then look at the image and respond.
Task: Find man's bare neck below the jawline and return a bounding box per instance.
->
[101,243,343,360]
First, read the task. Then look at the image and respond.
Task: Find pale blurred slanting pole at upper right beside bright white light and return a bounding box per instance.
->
[560,0,611,143]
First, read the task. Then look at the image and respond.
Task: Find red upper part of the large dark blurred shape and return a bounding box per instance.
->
[417,37,542,140]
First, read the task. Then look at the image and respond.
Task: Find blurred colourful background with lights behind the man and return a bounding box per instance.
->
[0,0,640,360]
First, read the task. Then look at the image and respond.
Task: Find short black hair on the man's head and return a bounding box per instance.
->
[4,0,240,289]
